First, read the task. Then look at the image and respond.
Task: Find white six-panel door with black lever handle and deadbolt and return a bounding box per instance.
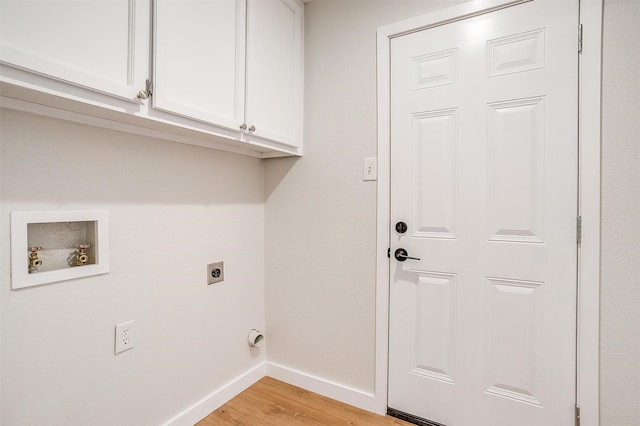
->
[388,0,578,426]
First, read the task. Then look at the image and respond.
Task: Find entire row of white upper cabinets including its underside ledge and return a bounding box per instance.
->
[0,0,303,158]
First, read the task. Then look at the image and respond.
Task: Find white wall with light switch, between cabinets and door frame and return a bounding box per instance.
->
[265,0,468,393]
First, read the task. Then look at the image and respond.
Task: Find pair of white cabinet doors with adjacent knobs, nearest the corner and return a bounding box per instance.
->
[153,0,302,147]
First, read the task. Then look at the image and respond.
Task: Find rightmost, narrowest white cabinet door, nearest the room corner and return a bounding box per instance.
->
[246,0,302,146]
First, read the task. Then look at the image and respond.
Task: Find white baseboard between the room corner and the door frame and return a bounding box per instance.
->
[265,362,375,412]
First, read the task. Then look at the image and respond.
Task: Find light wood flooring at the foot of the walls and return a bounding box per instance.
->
[197,377,412,426]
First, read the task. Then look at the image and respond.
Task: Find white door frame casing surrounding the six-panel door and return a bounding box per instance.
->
[374,0,603,426]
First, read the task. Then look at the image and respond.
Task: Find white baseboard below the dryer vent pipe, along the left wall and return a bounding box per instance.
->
[163,363,266,426]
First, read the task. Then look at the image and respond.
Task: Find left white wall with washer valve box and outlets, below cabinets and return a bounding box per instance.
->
[0,110,264,426]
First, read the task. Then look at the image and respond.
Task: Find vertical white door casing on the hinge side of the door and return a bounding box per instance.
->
[576,0,603,426]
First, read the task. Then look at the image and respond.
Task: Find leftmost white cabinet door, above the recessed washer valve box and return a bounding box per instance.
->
[0,0,150,101]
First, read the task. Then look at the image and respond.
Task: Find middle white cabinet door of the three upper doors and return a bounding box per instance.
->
[153,0,246,131]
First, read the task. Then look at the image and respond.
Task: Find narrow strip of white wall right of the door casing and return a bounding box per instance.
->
[600,0,640,426]
